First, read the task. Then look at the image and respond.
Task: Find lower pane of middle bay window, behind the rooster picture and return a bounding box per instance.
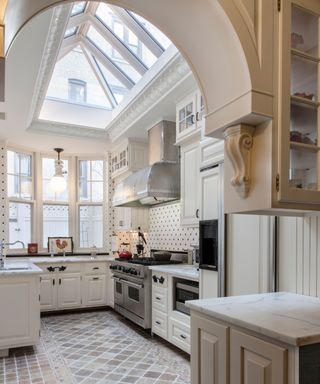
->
[43,204,69,248]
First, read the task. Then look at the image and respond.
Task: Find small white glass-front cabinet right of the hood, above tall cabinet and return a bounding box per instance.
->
[176,91,204,144]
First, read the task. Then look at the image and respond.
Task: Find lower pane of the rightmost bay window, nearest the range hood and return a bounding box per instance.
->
[79,205,103,248]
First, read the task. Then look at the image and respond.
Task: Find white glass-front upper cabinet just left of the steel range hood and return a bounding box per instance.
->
[111,139,148,178]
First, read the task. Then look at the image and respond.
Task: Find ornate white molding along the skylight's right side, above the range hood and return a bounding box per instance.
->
[106,54,192,142]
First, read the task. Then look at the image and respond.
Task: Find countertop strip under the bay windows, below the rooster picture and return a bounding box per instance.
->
[7,256,114,264]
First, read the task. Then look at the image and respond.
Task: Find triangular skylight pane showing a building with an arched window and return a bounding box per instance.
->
[47,46,111,109]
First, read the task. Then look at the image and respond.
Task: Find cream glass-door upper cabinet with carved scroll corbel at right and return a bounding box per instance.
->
[224,0,320,216]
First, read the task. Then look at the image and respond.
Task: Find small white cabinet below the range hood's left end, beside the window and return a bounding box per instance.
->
[114,207,149,232]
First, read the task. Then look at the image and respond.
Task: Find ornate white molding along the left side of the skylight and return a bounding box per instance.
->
[27,3,72,127]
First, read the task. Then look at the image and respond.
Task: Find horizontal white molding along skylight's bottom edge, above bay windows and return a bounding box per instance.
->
[27,120,109,141]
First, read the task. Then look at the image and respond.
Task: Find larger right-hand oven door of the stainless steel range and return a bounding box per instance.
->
[122,280,145,319]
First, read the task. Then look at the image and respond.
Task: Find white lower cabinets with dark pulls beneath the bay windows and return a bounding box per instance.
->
[39,262,109,312]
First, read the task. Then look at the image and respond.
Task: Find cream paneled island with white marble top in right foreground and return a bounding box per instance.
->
[187,292,320,384]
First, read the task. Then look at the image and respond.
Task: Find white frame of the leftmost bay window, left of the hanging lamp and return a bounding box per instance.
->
[6,146,36,250]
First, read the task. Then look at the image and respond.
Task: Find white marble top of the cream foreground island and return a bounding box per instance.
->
[186,292,320,346]
